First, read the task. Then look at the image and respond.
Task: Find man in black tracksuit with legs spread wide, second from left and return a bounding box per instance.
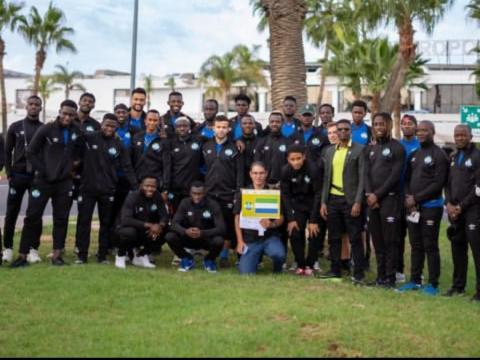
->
[12,100,82,267]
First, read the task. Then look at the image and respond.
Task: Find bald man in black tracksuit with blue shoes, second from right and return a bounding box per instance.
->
[399,121,448,295]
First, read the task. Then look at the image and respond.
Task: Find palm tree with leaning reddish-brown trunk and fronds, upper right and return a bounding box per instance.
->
[358,0,453,112]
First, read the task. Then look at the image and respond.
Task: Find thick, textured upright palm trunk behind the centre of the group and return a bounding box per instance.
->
[262,0,307,109]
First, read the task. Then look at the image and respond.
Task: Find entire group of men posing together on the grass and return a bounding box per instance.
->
[2,88,480,300]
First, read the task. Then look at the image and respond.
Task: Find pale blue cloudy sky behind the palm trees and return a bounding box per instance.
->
[2,0,480,76]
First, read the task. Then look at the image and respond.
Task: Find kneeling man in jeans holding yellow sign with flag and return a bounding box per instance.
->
[234,162,285,274]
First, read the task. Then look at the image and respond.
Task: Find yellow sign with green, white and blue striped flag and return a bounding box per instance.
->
[242,189,281,219]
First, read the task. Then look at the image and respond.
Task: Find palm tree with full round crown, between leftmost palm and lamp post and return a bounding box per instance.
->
[19,3,77,94]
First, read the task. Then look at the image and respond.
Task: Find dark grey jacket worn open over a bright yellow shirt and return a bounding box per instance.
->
[322,142,365,206]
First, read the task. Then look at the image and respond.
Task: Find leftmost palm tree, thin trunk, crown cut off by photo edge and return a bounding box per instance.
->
[0,0,23,133]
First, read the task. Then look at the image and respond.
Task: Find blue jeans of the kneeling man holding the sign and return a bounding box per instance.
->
[238,236,286,274]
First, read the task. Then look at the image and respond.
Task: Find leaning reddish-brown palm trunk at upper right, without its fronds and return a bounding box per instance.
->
[380,19,416,113]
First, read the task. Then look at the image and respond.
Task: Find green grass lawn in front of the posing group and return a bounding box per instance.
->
[0,222,480,357]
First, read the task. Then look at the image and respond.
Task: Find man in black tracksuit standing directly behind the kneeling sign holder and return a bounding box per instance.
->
[255,112,292,184]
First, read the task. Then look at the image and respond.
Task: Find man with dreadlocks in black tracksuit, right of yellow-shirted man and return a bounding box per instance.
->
[365,113,405,288]
